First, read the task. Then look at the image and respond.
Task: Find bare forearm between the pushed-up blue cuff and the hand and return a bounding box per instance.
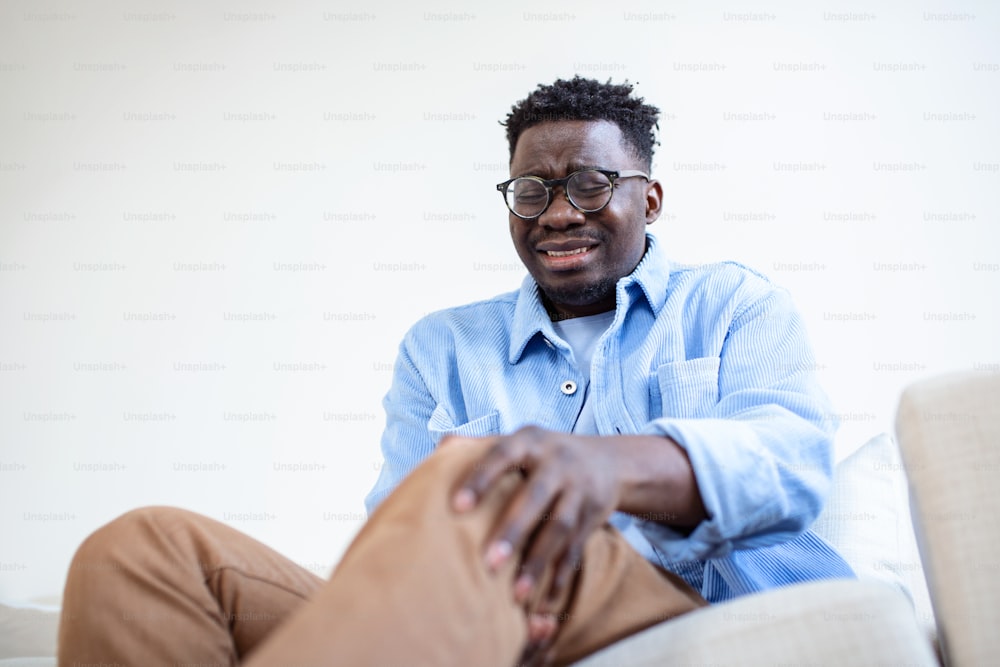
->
[602,435,707,528]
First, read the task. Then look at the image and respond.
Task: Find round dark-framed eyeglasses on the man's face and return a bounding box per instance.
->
[497,169,649,220]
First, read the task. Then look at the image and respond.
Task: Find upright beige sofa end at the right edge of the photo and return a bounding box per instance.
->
[896,372,1000,666]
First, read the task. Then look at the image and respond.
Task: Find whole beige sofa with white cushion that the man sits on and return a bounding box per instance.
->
[0,372,1000,667]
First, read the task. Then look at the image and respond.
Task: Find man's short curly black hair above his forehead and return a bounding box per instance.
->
[500,75,660,170]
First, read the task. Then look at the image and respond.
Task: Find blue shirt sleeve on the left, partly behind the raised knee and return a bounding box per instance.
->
[365,332,436,516]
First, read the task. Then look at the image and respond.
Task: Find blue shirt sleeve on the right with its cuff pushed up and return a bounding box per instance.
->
[637,289,837,561]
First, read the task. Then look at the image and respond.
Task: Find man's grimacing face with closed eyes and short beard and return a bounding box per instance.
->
[510,121,662,317]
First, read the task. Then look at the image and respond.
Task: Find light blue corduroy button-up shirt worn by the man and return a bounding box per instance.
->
[366,235,854,602]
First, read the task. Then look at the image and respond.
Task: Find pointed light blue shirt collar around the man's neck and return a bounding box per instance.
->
[508,233,670,364]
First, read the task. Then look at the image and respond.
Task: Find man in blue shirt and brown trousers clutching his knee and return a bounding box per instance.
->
[60,78,852,667]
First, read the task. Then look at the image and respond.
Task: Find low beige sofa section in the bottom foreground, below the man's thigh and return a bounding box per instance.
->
[576,579,938,667]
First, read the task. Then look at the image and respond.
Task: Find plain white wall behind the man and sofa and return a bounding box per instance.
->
[0,0,1000,599]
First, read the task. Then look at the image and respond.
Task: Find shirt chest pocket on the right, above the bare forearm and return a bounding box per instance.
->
[650,357,720,419]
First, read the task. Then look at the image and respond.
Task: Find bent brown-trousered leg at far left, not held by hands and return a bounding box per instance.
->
[59,507,322,667]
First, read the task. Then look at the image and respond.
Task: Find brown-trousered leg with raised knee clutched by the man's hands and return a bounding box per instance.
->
[248,438,705,667]
